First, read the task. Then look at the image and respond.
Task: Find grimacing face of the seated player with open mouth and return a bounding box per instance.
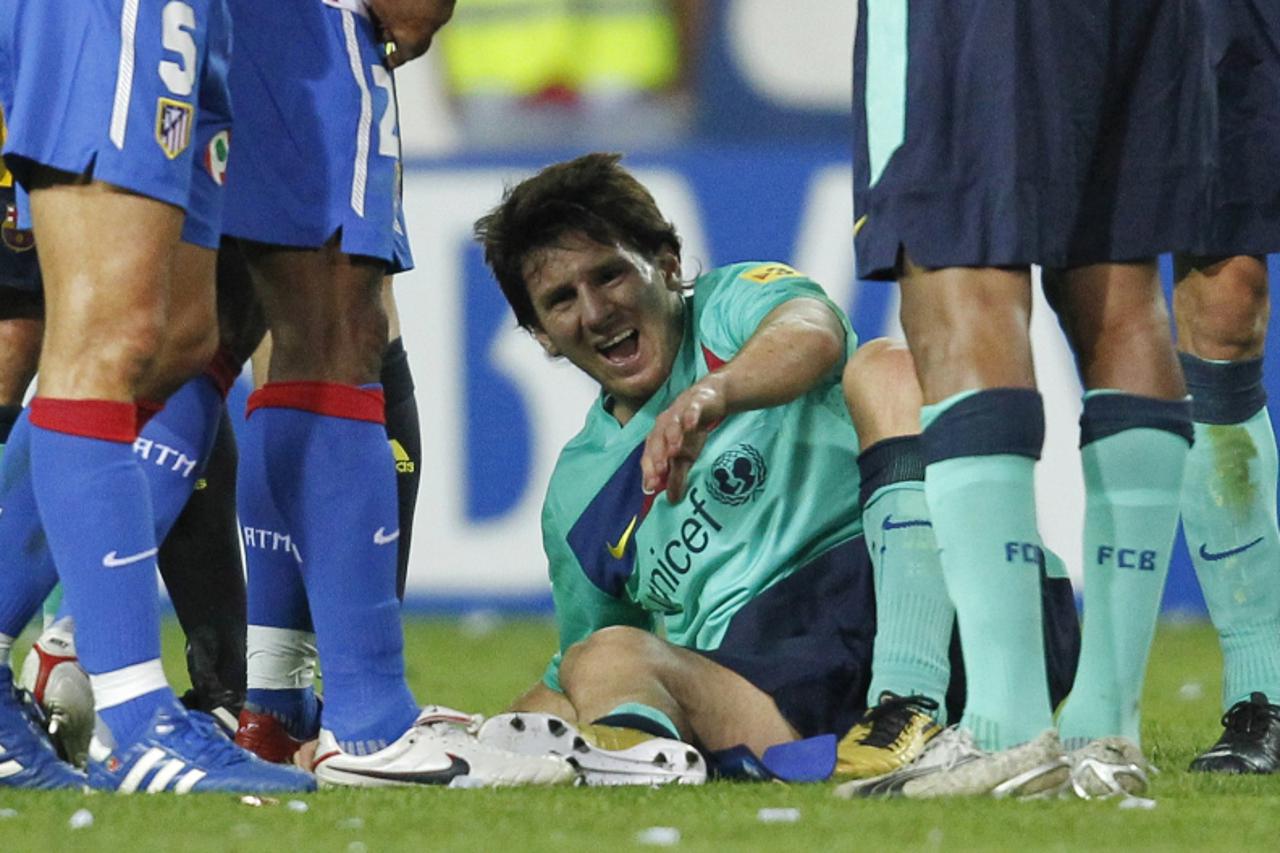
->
[525,234,684,423]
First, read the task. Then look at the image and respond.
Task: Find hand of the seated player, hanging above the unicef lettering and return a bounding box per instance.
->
[640,373,728,503]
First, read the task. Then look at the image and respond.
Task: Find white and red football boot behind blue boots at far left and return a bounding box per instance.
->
[18,616,96,767]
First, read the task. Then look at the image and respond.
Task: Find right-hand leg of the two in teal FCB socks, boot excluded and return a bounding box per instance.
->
[1044,263,1190,745]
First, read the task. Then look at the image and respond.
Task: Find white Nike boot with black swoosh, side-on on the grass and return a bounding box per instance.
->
[315,704,579,788]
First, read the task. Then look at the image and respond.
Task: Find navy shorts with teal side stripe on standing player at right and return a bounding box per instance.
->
[854,0,1217,279]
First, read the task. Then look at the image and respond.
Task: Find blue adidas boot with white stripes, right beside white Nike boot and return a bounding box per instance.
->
[88,708,316,794]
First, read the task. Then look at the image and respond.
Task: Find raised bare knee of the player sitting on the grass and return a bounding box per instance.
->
[842,338,923,450]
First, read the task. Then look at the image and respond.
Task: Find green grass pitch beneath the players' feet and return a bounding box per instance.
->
[0,620,1280,853]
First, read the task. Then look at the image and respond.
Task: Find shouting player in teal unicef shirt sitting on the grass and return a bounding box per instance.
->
[465,154,1078,784]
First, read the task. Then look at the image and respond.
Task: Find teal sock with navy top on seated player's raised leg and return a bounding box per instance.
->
[858,435,955,722]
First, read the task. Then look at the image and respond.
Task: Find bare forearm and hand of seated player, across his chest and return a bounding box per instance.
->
[640,298,845,503]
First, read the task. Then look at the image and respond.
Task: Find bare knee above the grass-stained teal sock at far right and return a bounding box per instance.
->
[1174,256,1271,360]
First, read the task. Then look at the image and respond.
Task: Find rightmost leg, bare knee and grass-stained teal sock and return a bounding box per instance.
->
[1174,255,1280,737]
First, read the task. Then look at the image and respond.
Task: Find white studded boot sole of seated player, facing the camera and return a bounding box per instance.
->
[476,713,707,785]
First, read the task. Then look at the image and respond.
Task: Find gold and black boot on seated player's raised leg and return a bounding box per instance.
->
[836,692,942,779]
